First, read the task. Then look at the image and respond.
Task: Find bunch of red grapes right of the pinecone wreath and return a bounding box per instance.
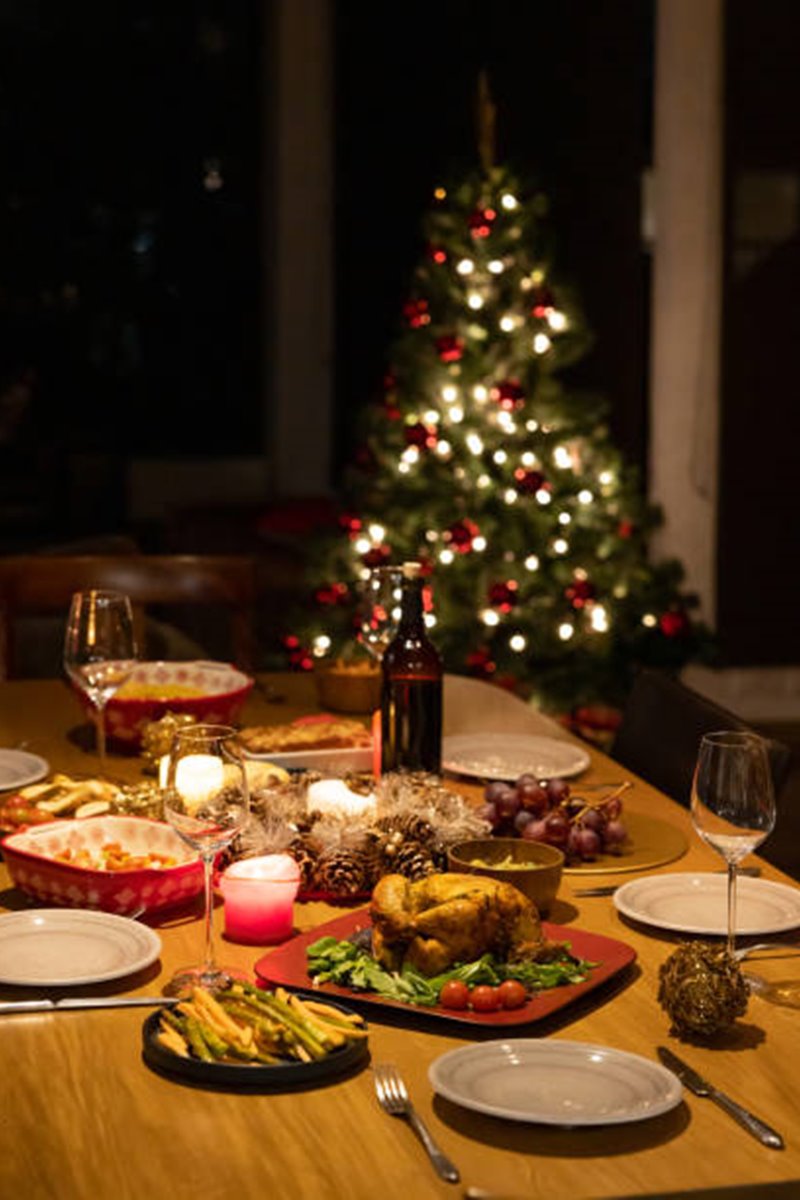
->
[479,775,627,860]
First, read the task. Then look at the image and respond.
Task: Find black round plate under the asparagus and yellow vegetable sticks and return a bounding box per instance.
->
[142,996,369,1091]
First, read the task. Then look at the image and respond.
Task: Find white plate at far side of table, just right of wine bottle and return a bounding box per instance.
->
[441,733,590,780]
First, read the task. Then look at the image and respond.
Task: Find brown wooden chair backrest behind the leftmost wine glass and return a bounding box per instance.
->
[0,554,257,678]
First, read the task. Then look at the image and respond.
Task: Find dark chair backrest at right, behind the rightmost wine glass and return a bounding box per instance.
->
[610,668,792,805]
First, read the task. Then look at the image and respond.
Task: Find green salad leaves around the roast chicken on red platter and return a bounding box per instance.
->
[306,937,596,1007]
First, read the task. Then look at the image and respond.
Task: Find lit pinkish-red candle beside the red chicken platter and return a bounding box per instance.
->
[219,854,300,946]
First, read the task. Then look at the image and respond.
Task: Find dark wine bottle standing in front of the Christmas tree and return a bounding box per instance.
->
[380,563,444,774]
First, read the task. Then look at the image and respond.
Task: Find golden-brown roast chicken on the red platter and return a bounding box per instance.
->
[371,872,554,976]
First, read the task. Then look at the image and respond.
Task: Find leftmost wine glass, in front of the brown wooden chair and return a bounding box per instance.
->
[64,588,137,774]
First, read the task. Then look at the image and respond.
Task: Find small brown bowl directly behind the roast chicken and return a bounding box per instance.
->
[447,838,564,917]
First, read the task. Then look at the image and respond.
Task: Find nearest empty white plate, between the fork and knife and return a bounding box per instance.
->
[428,1038,682,1126]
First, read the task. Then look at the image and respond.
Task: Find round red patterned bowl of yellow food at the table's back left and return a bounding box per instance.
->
[106,662,253,751]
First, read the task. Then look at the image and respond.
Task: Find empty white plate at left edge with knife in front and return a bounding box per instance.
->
[0,908,161,988]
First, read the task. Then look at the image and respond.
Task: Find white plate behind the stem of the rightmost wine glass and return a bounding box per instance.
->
[614,872,800,935]
